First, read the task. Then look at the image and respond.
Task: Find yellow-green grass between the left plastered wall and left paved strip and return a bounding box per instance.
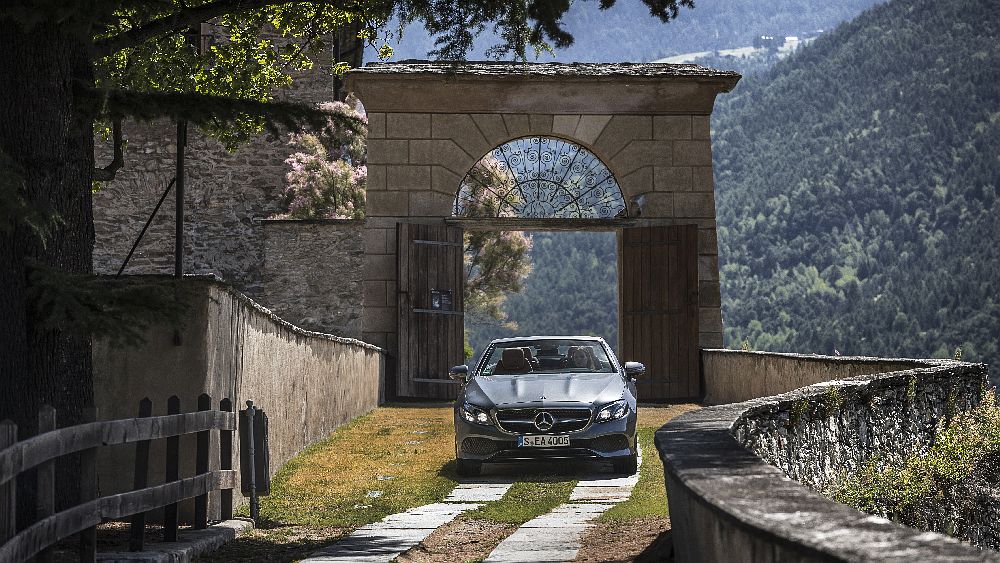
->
[211,405,456,561]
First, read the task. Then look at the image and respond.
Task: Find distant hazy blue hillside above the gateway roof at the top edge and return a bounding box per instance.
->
[376,0,882,62]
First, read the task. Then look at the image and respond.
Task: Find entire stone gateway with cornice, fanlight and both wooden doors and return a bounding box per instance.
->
[347,61,740,401]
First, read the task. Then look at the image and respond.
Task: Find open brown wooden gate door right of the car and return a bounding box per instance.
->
[618,225,701,401]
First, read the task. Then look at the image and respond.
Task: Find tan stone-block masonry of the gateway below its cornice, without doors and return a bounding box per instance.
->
[362,109,722,350]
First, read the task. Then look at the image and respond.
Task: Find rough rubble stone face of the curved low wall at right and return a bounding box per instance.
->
[732,361,987,491]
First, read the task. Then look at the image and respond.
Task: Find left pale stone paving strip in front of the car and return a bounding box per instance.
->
[305,478,512,563]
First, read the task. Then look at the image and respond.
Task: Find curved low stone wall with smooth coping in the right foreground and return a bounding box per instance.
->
[656,352,1000,562]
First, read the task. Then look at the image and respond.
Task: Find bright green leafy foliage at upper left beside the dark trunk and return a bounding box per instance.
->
[94,1,391,148]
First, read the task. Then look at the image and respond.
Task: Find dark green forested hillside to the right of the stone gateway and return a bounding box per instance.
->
[713,0,1000,363]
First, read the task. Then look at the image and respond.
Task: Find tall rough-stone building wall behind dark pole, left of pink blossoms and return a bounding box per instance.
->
[93,33,344,300]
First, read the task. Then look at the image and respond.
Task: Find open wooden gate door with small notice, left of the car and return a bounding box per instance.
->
[396,223,465,399]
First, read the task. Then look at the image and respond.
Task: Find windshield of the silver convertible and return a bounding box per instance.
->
[479,340,615,375]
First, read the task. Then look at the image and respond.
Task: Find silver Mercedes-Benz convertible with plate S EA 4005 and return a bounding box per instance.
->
[451,336,645,475]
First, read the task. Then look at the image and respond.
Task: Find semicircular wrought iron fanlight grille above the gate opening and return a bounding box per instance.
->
[454,137,625,219]
